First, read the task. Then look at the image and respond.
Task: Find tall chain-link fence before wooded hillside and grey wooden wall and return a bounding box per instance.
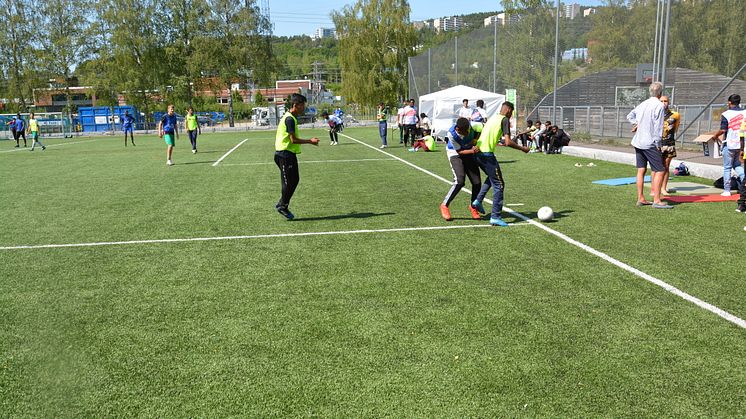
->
[409,0,746,146]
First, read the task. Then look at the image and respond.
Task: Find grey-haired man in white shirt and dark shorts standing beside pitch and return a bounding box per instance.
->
[627,81,673,209]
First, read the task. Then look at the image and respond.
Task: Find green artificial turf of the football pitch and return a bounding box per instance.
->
[0,128,746,417]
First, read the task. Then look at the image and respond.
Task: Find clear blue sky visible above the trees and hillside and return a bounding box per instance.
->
[269,0,601,36]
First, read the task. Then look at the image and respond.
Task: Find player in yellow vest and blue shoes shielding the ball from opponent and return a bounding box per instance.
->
[471,102,529,227]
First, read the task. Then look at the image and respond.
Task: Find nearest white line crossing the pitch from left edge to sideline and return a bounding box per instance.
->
[0,223,528,250]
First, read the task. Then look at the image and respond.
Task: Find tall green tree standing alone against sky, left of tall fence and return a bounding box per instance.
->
[332,0,417,106]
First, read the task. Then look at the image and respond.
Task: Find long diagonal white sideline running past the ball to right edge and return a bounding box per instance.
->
[339,133,746,329]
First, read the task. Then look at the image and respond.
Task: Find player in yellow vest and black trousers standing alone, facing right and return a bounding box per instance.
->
[275,93,319,220]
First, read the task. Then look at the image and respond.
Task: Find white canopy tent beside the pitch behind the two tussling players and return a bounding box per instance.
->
[419,85,505,137]
